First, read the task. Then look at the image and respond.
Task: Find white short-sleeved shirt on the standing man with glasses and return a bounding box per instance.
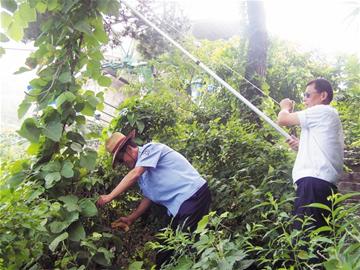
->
[292,105,344,184]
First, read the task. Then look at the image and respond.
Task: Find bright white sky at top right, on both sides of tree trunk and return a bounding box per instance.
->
[177,0,360,55]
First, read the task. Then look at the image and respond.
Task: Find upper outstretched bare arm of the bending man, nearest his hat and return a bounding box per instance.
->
[96,167,145,206]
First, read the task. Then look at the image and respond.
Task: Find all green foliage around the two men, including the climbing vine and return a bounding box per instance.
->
[0,0,360,269]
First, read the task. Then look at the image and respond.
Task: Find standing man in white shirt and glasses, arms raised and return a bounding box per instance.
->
[278,79,344,230]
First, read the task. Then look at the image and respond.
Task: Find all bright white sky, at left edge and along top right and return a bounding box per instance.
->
[0,0,360,130]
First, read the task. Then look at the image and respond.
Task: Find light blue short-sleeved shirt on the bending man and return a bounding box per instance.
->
[135,143,206,216]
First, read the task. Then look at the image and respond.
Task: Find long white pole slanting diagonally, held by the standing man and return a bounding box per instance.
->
[121,0,291,139]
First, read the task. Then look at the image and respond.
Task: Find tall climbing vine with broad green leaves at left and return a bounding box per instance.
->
[0,0,119,269]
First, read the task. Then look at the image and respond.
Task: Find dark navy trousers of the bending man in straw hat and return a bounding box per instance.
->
[155,183,211,269]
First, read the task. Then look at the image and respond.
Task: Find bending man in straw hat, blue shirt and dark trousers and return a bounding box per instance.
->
[97,131,211,267]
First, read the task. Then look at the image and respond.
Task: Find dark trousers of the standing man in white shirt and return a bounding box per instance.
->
[294,177,337,269]
